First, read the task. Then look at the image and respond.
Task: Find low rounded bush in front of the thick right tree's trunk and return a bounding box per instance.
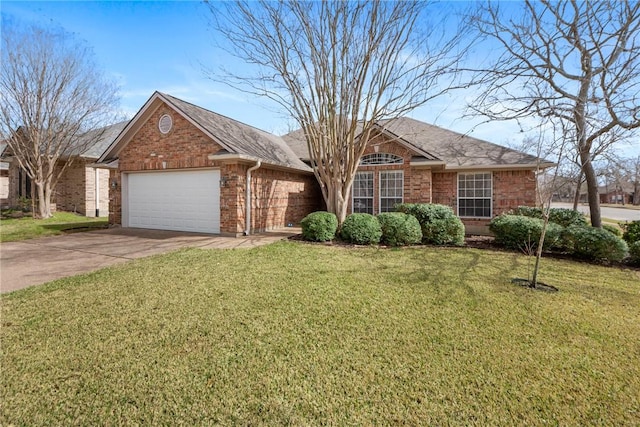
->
[563,225,629,261]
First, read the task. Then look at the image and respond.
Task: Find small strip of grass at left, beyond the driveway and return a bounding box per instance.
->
[0,212,108,242]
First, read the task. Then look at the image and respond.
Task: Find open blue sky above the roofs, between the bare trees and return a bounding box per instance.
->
[0,0,636,157]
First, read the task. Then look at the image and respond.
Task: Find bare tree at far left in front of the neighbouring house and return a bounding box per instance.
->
[0,19,117,218]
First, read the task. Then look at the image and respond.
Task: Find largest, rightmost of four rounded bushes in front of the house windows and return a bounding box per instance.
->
[396,203,464,246]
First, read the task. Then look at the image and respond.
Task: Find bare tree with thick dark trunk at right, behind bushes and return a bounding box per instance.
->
[470,0,640,227]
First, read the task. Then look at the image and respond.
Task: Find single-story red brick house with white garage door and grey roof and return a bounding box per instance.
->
[99,92,550,235]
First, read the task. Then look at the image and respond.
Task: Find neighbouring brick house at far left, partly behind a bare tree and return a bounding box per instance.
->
[2,121,127,217]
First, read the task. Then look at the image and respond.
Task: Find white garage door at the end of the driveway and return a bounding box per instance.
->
[123,170,220,233]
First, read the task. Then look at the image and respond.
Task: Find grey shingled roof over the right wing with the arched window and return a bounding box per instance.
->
[282,117,552,169]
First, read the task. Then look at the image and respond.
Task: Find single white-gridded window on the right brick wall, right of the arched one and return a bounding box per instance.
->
[458,172,492,218]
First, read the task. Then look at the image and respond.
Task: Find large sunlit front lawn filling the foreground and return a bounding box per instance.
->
[0,242,640,426]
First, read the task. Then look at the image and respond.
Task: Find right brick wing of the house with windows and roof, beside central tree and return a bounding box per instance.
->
[283,117,553,233]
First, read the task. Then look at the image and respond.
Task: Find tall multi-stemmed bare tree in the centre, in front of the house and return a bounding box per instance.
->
[209,1,470,223]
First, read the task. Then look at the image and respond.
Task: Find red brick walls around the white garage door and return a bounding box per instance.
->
[109,105,321,235]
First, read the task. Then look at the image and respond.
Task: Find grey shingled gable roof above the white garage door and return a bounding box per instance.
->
[100,92,311,172]
